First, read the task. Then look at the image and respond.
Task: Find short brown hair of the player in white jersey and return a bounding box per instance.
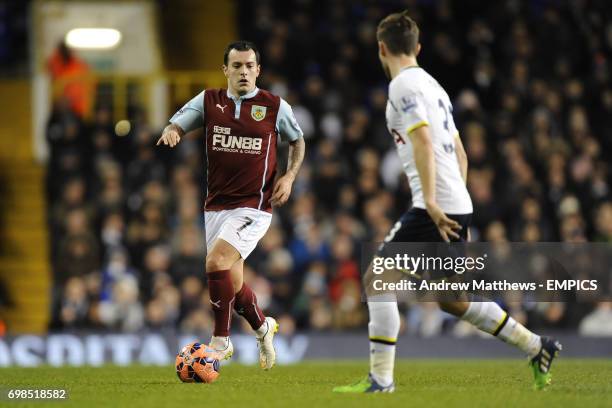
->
[376,11,419,55]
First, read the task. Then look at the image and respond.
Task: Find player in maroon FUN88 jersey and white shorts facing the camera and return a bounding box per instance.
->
[157,41,305,370]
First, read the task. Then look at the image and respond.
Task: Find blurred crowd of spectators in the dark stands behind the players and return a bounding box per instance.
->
[47,0,612,335]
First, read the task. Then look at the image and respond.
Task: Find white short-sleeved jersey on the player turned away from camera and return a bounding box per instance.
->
[386,67,472,214]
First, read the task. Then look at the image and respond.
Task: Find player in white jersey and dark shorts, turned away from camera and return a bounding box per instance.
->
[334,12,561,393]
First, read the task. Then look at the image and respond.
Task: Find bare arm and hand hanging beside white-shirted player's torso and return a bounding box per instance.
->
[408,126,461,242]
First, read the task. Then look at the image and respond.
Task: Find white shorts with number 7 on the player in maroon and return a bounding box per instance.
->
[204,208,272,259]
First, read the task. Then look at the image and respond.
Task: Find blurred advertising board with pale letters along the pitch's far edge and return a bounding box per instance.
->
[0,333,612,367]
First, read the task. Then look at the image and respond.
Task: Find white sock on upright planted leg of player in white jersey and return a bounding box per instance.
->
[368,297,400,387]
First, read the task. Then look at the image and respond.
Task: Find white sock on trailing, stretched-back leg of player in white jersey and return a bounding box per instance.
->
[461,302,542,357]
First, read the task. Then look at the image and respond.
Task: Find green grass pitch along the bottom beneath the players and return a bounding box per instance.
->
[0,358,612,408]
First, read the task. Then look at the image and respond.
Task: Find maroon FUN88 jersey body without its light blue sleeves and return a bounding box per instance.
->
[204,89,280,212]
